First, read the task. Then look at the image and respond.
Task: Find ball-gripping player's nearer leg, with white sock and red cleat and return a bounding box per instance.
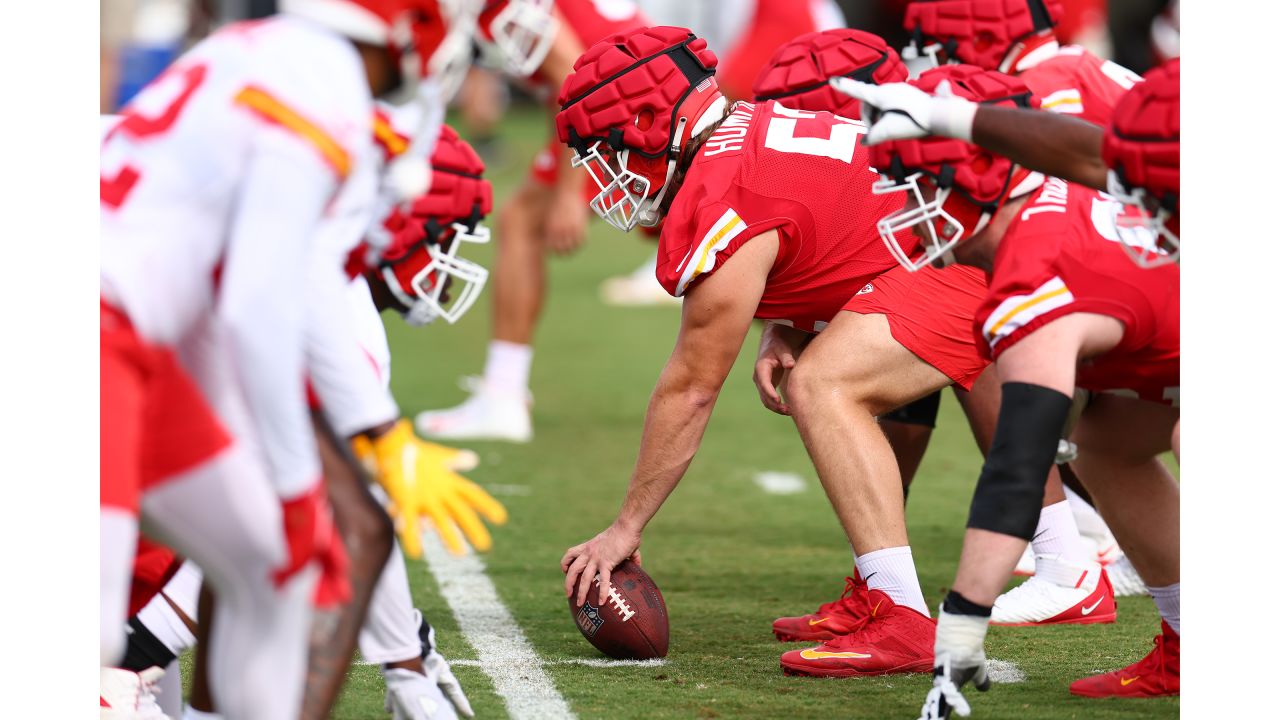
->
[781,311,952,676]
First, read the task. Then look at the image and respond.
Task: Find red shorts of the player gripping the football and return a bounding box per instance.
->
[844,265,989,389]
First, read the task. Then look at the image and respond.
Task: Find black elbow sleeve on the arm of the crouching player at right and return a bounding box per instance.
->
[969,383,1071,541]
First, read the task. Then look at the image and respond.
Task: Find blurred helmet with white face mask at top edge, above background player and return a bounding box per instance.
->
[477,0,559,77]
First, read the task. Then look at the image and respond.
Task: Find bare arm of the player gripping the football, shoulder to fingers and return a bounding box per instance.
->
[561,231,778,605]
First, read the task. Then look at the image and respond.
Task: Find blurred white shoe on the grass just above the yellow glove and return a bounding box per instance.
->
[413,377,534,442]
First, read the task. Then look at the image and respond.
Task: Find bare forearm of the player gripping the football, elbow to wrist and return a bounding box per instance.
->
[617,365,719,533]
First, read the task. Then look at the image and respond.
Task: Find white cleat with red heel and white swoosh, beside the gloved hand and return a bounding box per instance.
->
[991,555,1116,625]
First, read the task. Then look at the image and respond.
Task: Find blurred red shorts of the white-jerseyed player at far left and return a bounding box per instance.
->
[99,297,232,515]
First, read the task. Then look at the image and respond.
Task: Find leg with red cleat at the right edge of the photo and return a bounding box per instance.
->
[1071,395,1181,697]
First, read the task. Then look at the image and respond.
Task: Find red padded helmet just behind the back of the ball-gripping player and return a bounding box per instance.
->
[751,28,906,119]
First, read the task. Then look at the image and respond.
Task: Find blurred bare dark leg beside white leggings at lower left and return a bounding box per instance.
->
[301,414,394,720]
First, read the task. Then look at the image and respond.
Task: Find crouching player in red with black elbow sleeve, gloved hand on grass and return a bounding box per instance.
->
[872,67,1180,719]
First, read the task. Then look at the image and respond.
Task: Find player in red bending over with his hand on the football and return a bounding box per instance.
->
[557,27,1013,676]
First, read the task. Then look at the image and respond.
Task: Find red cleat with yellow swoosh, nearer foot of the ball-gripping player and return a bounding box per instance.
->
[781,591,936,678]
